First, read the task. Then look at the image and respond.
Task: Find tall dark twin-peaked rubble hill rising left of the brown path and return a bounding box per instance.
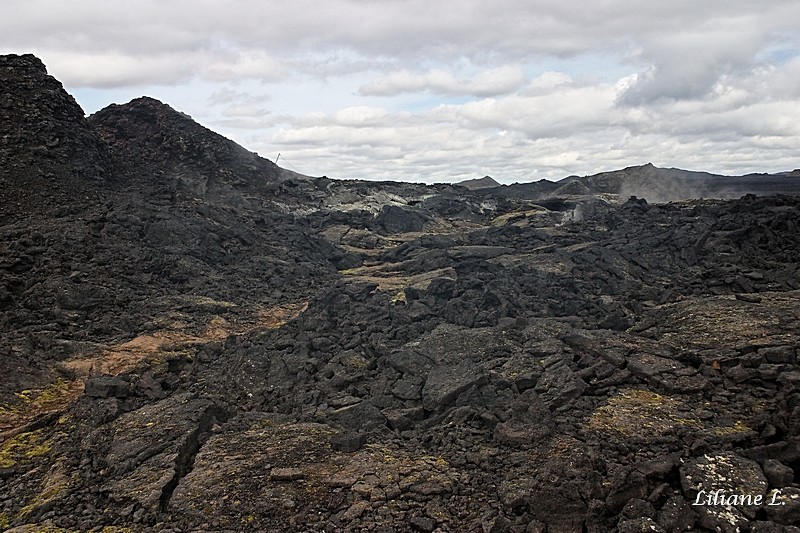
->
[0,56,344,406]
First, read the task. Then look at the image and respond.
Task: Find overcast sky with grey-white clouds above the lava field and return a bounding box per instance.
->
[0,0,800,183]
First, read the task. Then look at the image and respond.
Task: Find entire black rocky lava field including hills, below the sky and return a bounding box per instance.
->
[0,52,800,533]
